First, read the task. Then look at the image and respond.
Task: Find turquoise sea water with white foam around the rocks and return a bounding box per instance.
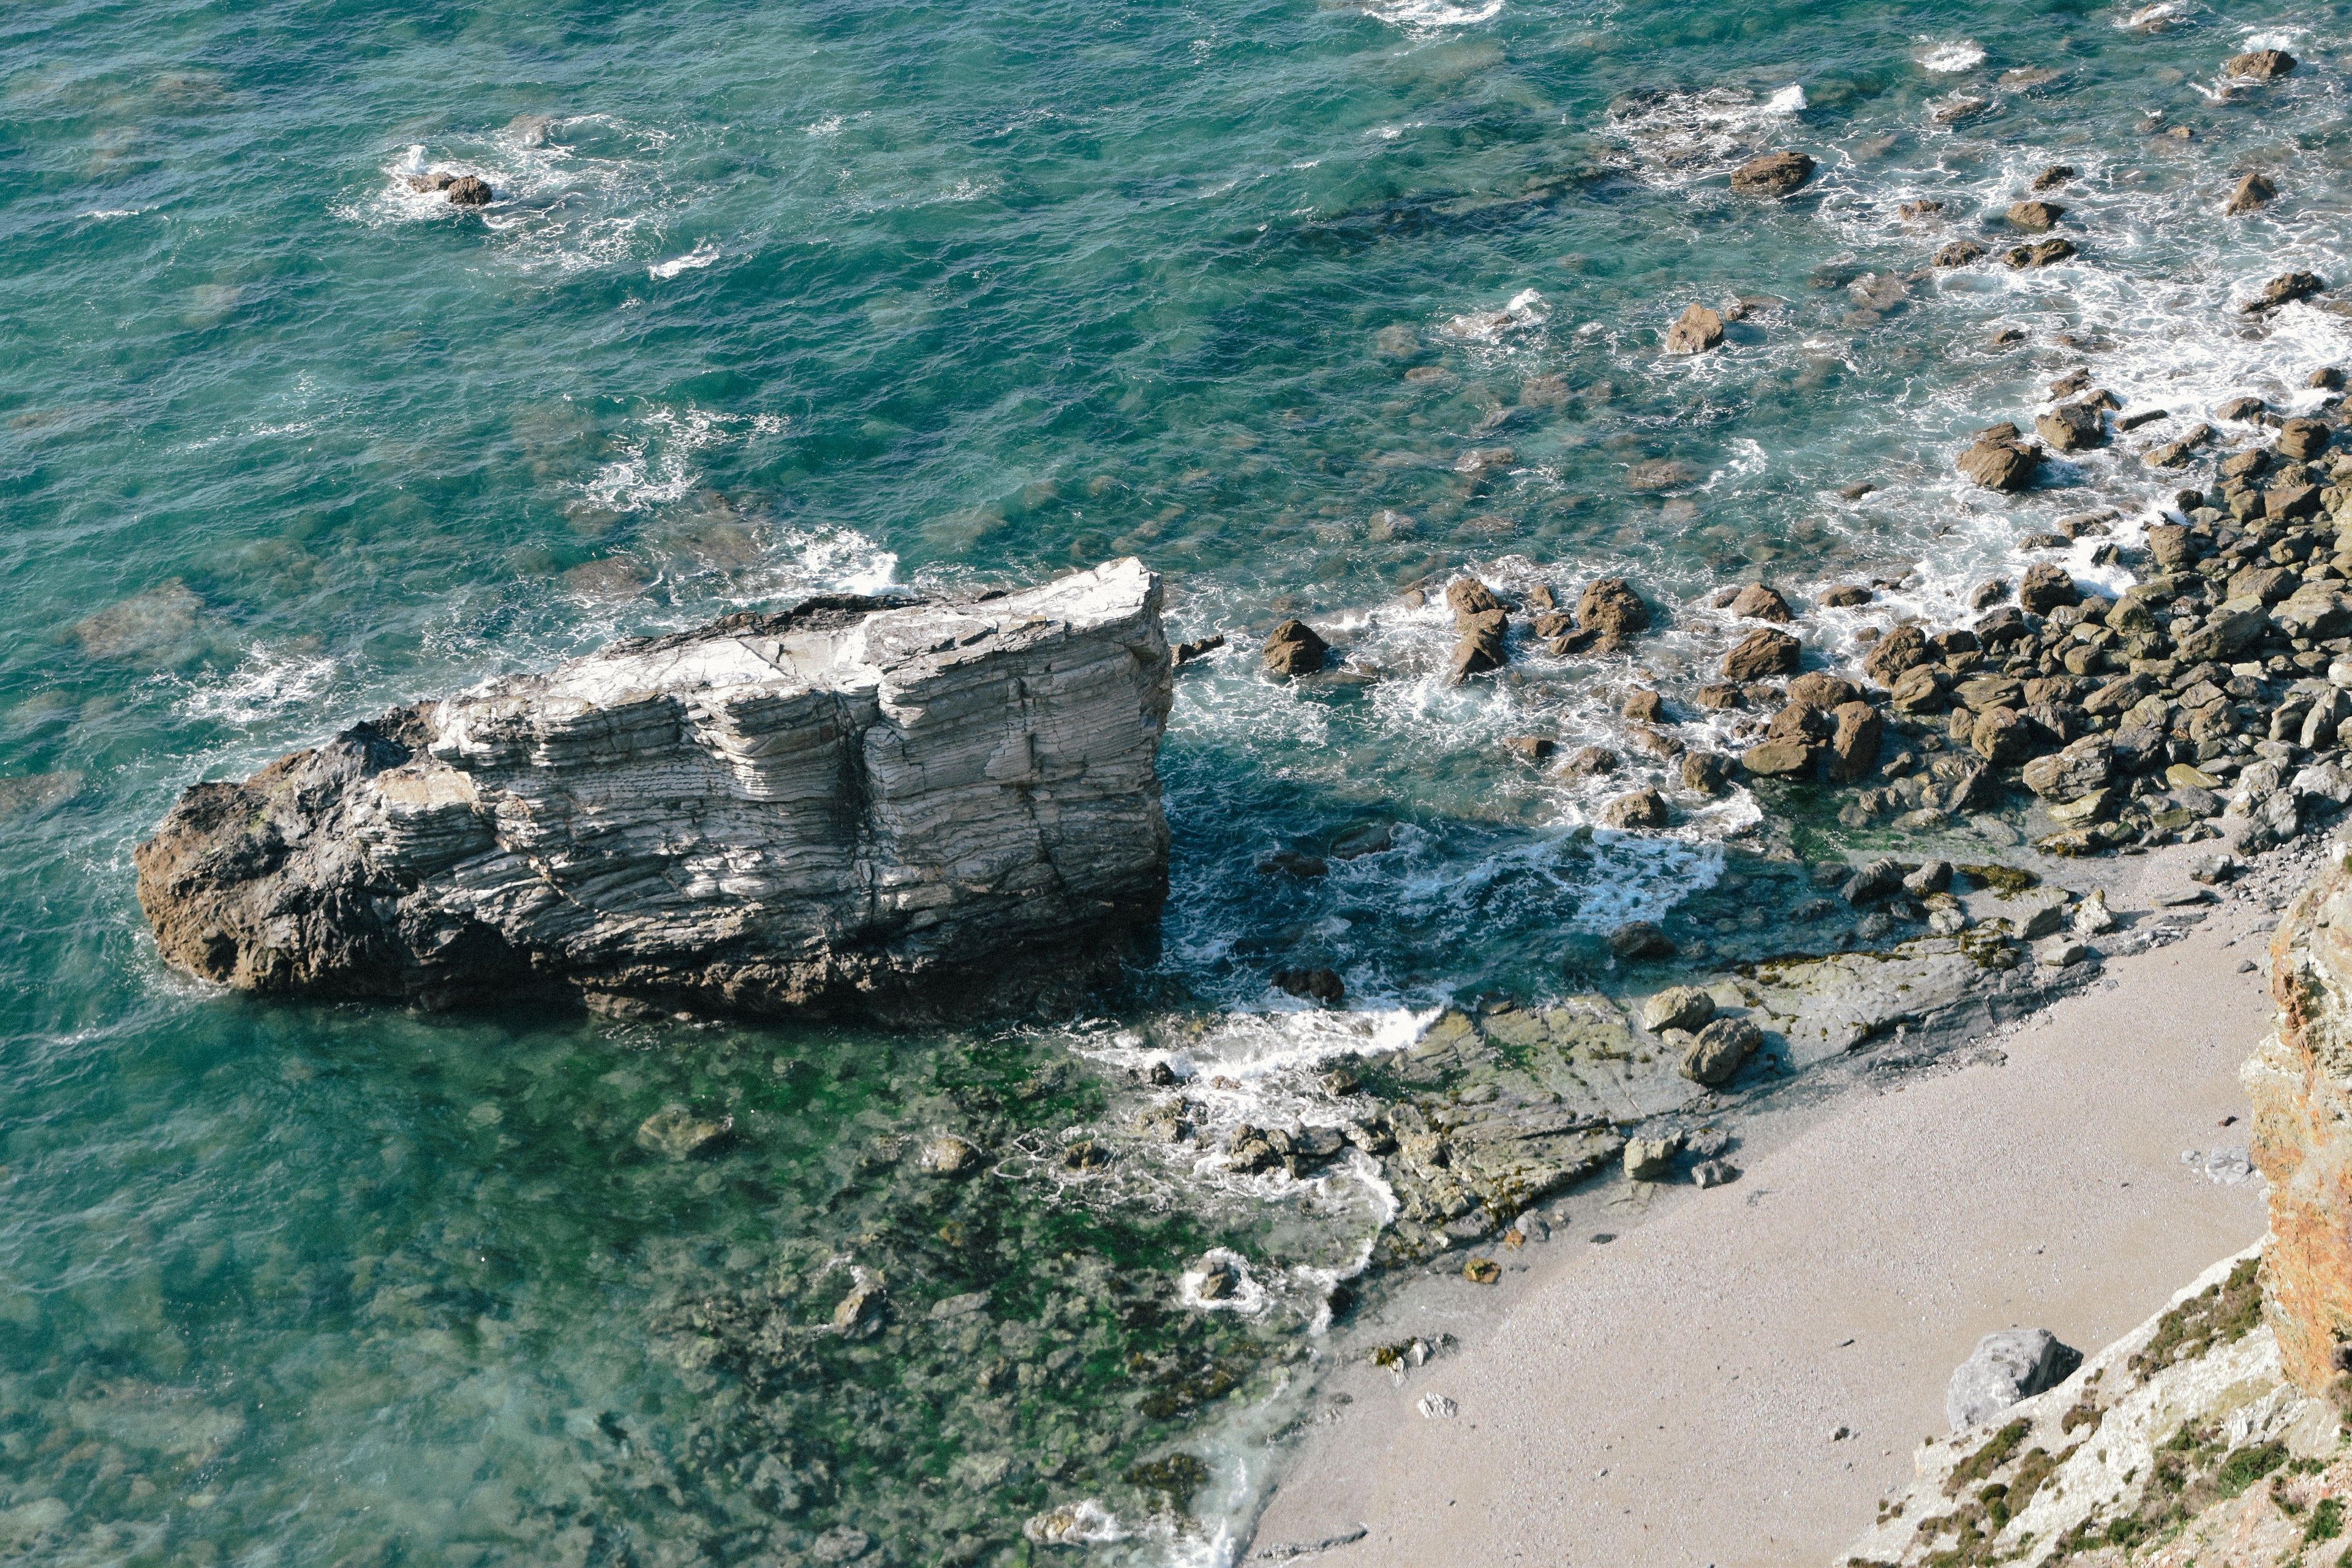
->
[0,0,2352,1563]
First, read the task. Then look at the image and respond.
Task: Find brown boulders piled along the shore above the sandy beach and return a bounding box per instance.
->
[1265,350,2352,893]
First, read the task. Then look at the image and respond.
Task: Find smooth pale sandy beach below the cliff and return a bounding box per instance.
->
[1251,851,2301,1568]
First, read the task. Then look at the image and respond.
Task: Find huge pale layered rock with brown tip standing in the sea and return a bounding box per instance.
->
[137,559,1171,1023]
